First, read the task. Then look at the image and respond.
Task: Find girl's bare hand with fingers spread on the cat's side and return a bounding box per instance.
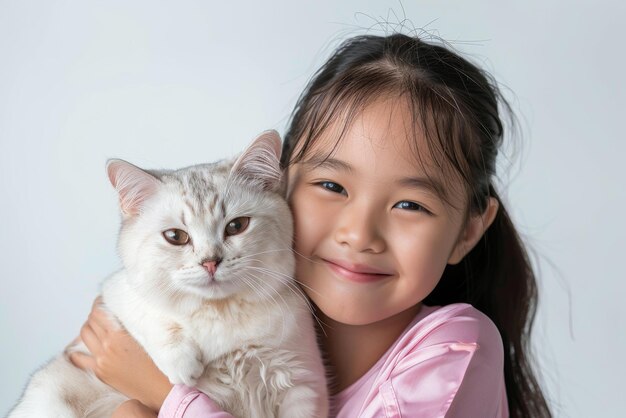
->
[69,297,172,411]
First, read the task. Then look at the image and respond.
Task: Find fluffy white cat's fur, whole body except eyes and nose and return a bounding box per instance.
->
[9,131,328,418]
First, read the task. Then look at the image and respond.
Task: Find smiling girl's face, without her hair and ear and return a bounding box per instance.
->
[288,100,472,325]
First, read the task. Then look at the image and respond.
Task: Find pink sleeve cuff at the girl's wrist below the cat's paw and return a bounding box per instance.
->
[159,385,233,418]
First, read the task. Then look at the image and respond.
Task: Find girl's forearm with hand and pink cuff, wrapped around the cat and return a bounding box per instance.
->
[69,298,232,418]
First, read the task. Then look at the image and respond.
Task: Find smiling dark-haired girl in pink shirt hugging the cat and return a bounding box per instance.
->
[72,34,550,417]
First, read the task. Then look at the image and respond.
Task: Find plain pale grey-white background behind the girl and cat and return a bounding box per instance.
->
[0,0,626,417]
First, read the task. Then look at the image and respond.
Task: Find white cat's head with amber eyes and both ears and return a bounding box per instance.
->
[107,131,294,299]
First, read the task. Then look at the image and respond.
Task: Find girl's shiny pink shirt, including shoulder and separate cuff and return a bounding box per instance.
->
[159,303,509,418]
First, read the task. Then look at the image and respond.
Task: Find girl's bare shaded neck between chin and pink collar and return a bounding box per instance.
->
[316,303,421,395]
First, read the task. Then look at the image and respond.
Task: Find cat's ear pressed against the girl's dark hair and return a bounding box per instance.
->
[230,130,282,190]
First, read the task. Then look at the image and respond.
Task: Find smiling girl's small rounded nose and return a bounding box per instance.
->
[334,205,386,254]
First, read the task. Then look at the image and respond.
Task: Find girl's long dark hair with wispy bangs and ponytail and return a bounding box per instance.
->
[281,34,551,418]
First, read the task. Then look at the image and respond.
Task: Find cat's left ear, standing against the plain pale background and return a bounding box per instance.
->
[106,159,161,216]
